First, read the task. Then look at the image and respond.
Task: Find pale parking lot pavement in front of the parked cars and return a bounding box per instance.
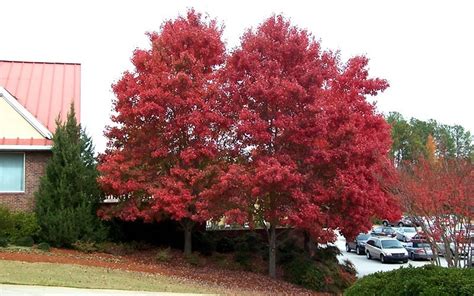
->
[335,236,447,277]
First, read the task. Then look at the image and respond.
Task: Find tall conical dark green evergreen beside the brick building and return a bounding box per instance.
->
[35,105,105,246]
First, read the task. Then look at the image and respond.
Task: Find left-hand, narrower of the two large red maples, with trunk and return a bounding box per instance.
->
[99,10,228,254]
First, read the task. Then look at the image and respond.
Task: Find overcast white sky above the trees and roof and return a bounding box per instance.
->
[0,0,474,151]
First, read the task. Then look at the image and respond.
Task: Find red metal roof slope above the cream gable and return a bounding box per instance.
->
[0,60,81,133]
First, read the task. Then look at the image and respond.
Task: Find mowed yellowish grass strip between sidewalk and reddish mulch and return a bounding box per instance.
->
[0,260,215,293]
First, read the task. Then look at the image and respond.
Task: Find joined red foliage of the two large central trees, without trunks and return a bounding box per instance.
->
[99,11,397,245]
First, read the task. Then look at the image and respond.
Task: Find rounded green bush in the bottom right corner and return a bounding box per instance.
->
[344,265,474,296]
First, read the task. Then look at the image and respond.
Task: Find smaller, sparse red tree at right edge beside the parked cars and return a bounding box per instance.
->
[398,157,474,267]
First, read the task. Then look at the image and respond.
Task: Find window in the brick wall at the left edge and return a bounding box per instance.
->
[0,153,25,192]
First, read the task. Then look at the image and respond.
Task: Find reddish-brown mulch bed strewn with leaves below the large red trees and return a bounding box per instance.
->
[0,248,325,295]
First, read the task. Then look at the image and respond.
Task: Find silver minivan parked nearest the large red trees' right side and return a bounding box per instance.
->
[365,237,408,263]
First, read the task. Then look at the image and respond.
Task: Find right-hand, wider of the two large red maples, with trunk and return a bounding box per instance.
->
[202,16,398,277]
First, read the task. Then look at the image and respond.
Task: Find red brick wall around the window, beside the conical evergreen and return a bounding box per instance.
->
[0,151,51,211]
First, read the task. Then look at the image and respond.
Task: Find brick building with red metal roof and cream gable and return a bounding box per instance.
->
[0,60,81,210]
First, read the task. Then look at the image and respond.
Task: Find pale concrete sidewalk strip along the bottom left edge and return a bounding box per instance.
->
[0,285,205,296]
